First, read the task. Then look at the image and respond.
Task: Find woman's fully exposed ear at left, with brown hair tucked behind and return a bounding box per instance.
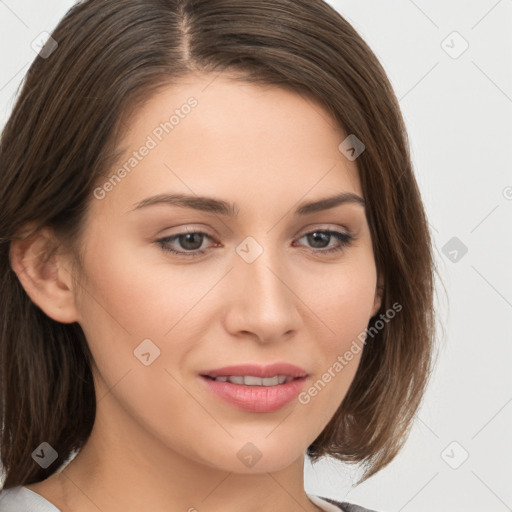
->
[9,228,79,323]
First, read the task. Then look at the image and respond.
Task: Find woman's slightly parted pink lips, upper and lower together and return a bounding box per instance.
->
[200,363,307,412]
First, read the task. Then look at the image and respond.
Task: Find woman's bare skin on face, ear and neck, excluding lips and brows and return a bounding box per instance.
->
[11,75,380,512]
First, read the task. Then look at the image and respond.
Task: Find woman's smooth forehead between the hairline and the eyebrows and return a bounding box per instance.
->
[94,74,362,215]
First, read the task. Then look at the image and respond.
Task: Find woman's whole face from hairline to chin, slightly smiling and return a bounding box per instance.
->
[69,71,380,473]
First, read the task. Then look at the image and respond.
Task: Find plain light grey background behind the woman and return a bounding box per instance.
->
[0,0,512,512]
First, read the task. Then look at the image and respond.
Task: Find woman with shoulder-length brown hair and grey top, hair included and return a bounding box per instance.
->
[0,0,434,512]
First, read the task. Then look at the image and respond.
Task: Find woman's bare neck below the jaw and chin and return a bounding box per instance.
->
[38,372,319,512]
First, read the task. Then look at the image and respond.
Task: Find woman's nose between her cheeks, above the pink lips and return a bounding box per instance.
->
[224,243,302,342]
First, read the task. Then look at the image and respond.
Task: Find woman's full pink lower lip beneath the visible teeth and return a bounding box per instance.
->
[200,375,306,412]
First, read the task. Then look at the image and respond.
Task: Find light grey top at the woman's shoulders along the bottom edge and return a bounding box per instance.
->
[0,486,376,512]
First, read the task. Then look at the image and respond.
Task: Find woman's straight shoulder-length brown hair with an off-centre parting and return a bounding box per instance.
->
[0,0,435,489]
